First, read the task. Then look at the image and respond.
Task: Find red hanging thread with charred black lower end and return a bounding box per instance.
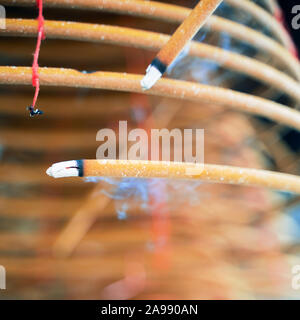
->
[28,0,45,117]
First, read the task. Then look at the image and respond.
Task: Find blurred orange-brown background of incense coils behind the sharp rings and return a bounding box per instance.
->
[0,0,300,299]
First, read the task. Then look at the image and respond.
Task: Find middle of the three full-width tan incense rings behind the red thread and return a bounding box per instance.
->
[0,19,300,102]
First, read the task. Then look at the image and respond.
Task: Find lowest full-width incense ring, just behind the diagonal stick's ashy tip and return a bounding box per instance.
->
[0,67,300,130]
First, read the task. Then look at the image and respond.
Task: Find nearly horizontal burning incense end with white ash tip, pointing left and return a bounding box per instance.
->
[47,160,300,193]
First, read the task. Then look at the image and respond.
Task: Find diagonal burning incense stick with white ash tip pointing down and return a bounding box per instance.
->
[141,0,222,90]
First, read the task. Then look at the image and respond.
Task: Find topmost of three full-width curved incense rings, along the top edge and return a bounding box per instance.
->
[0,0,300,80]
